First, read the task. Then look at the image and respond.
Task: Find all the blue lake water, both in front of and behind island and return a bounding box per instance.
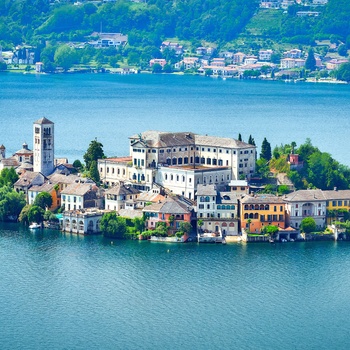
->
[0,74,350,350]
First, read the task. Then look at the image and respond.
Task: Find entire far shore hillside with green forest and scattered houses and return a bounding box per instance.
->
[0,0,350,81]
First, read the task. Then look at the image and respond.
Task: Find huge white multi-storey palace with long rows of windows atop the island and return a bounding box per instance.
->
[98,131,256,199]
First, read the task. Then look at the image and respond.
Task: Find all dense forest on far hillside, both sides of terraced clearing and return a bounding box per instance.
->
[0,0,350,47]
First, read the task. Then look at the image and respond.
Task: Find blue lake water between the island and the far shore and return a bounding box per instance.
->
[0,74,350,165]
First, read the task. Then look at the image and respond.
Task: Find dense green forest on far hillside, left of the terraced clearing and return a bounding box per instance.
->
[0,0,258,46]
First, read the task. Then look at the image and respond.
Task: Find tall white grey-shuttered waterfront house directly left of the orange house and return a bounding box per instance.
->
[196,184,239,236]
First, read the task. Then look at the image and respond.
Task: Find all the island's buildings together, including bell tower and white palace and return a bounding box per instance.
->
[0,118,350,243]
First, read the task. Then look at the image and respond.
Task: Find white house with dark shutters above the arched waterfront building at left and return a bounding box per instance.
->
[61,182,102,211]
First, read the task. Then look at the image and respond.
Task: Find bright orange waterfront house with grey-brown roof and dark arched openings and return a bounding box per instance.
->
[240,194,286,233]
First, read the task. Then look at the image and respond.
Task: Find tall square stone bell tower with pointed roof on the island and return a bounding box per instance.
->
[33,118,55,176]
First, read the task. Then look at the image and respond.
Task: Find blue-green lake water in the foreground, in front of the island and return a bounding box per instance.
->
[0,224,350,350]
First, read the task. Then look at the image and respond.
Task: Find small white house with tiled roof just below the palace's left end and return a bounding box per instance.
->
[105,181,141,212]
